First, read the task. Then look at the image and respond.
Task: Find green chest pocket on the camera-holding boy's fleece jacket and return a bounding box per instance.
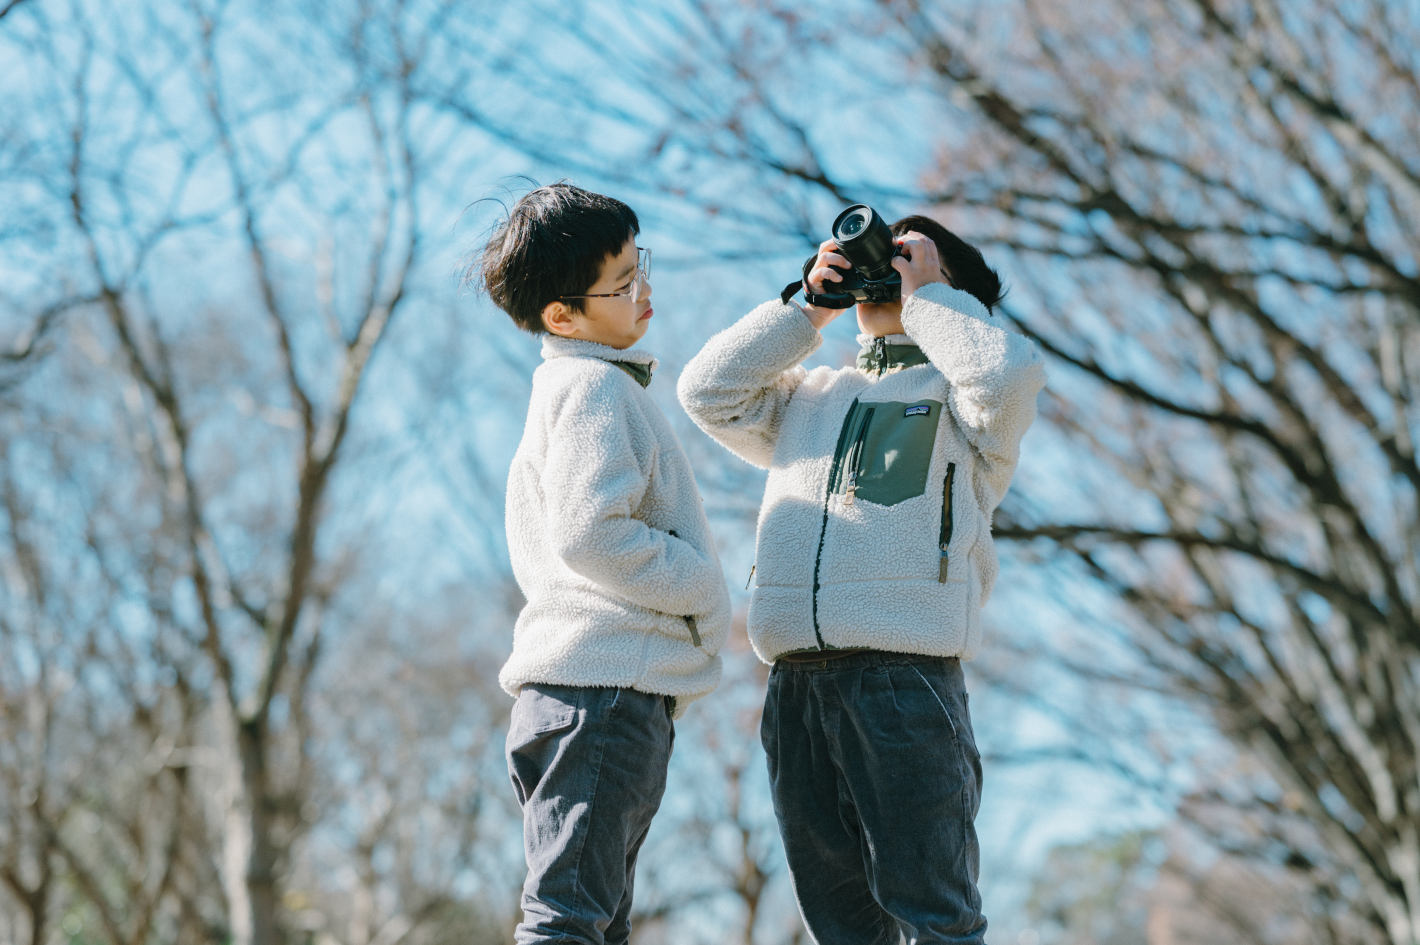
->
[828,401,941,506]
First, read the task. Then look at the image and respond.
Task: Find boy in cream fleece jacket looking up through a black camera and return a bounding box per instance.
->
[679,206,1045,945]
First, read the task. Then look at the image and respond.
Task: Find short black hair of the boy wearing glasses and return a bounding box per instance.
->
[464,180,640,334]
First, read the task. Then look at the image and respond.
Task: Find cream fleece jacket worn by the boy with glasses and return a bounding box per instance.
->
[498,335,730,716]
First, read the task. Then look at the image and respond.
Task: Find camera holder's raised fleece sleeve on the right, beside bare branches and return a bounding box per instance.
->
[902,283,1045,507]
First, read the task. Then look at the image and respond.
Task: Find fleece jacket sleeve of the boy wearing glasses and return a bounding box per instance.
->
[542,369,724,617]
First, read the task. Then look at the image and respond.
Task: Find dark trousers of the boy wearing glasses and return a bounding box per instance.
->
[507,685,676,945]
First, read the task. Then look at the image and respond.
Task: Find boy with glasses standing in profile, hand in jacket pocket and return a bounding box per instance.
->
[470,183,730,945]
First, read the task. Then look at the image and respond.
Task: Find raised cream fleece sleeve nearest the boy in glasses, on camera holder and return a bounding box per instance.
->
[676,301,824,469]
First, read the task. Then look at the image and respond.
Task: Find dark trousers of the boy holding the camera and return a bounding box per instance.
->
[760,652,985,945]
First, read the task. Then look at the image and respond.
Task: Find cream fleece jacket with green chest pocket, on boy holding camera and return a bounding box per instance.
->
[679,283,1045,662]
